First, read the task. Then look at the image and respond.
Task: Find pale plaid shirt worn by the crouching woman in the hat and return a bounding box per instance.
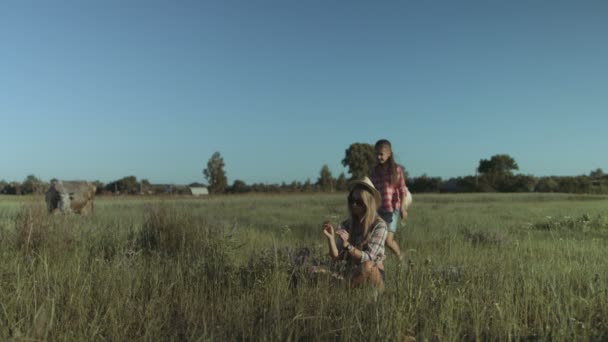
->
[338,219,388,270]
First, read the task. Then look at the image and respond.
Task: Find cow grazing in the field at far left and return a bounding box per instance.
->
[46,180,97,215]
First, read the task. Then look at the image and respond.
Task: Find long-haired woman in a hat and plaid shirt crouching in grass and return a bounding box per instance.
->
[323,177,387,289]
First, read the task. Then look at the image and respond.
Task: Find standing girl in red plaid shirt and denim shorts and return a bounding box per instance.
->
[370,139,411,259]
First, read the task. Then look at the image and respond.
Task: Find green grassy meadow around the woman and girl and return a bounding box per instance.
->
[0,194,608,341]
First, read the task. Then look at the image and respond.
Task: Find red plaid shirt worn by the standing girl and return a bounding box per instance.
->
[370,165,407,213]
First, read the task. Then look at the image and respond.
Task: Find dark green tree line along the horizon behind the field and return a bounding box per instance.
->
[0,143,608,195]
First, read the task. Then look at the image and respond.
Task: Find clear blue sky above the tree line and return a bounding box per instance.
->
[0,0,608,183]
